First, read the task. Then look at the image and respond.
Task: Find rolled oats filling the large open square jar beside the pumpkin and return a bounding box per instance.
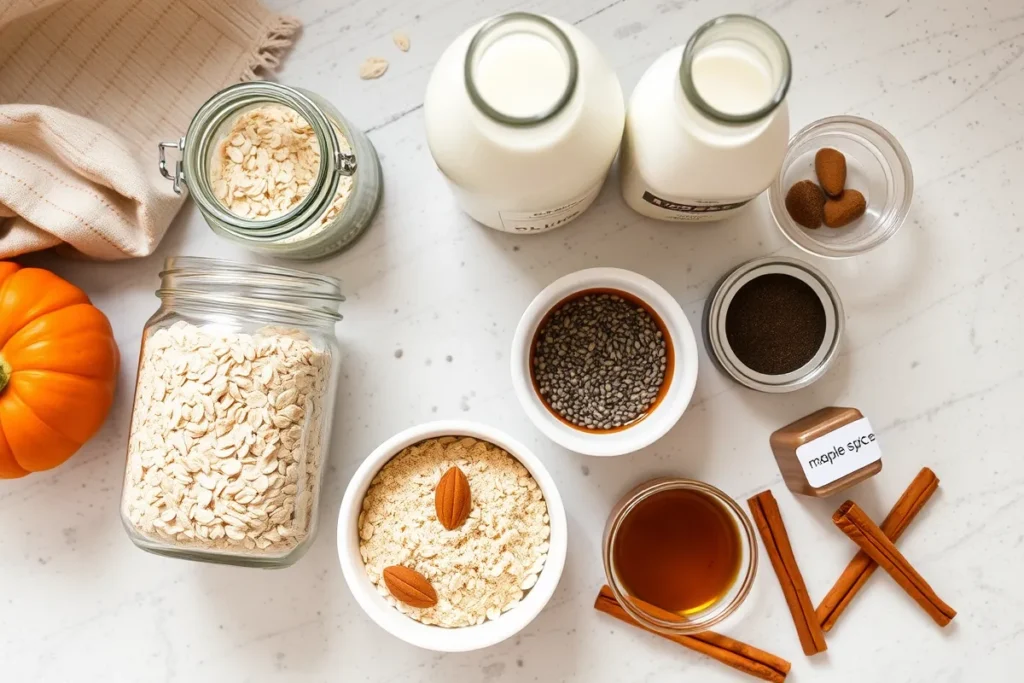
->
[122,322,330,554]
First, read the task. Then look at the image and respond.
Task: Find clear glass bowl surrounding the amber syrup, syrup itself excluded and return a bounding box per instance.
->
[602,477,758,635]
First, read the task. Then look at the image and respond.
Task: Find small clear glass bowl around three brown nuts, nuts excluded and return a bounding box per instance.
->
[768,116,913,258]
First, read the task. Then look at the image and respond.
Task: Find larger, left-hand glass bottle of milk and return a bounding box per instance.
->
[424,12,625,233]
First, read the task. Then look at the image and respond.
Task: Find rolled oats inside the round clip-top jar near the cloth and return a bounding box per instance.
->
[210,104,352,243]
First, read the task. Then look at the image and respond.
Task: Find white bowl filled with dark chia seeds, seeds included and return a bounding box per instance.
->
[512,268,697,456]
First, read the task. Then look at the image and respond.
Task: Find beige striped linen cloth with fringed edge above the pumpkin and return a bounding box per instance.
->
[0,0,298,259]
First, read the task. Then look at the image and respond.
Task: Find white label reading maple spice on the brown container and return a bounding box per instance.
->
[797,418,882,488]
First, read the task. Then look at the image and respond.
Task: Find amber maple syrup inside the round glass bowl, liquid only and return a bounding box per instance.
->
[611,488,742,616]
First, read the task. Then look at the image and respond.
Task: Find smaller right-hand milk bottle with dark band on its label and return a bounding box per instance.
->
[620,14,791,222]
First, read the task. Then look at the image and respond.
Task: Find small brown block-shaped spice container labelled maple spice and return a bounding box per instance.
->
[770,408,882,498]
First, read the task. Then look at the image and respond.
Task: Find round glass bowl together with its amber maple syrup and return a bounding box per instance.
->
[603,478,758,635]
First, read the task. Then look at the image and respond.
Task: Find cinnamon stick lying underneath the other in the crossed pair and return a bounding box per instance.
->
[815,467,939,632]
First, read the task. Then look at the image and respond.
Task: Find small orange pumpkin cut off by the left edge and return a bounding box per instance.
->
[0,261,119,479]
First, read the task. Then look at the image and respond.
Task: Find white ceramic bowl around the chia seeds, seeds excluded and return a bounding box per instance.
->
[512,268,697,456]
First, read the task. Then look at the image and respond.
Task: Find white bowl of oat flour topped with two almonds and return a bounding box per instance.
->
[338,421,566,652]
